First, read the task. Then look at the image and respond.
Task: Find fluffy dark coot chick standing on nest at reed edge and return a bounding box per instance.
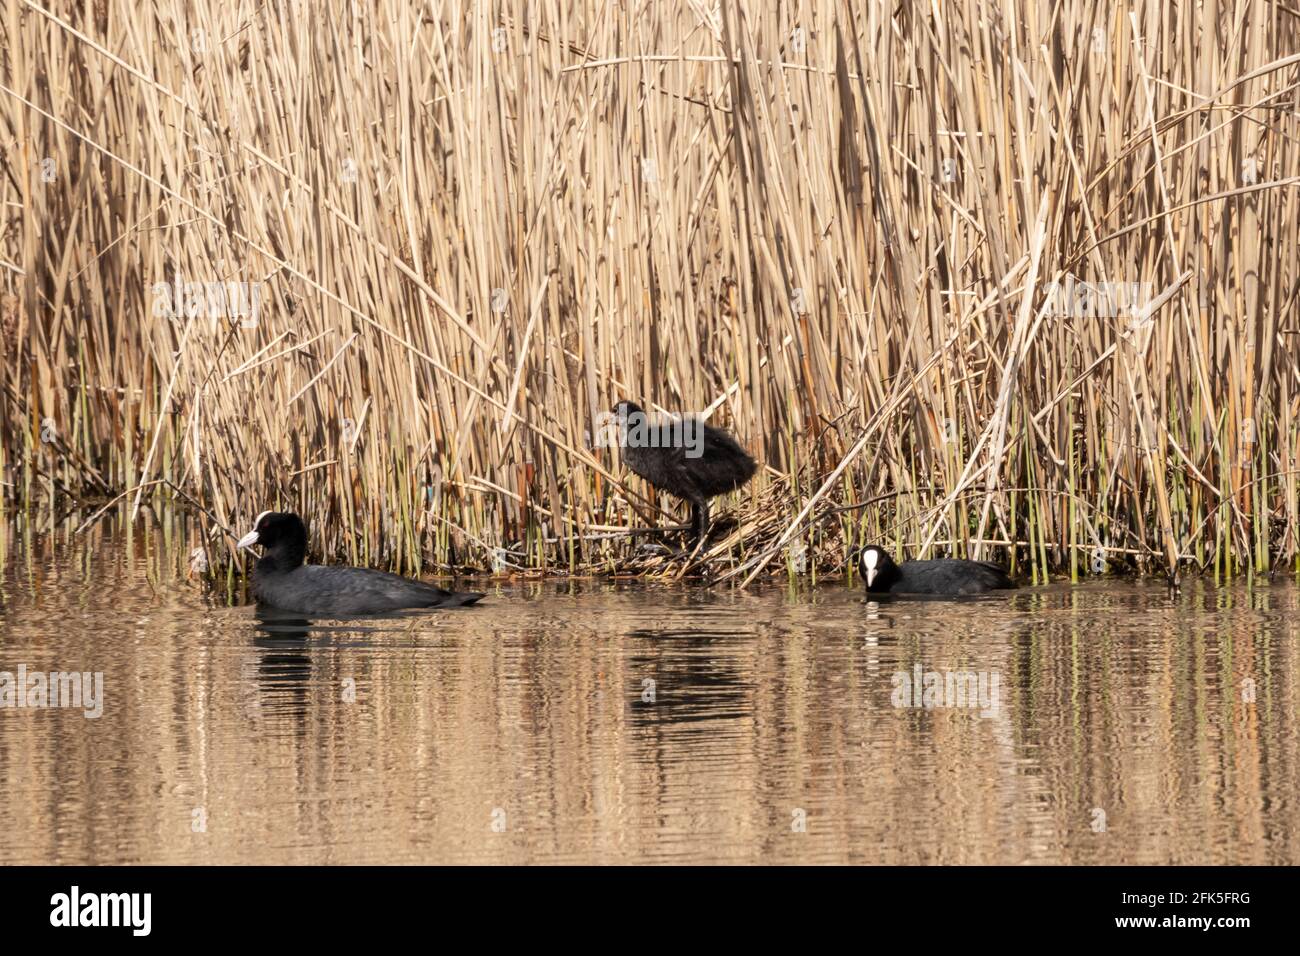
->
[614,402,758,540]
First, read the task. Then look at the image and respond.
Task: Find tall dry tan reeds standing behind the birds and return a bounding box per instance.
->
[0,0,1300,580]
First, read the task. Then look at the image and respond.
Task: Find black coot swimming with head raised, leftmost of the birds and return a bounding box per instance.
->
[239,511,482,617]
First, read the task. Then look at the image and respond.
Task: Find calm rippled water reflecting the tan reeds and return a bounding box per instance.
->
[0,537,1300,864]
